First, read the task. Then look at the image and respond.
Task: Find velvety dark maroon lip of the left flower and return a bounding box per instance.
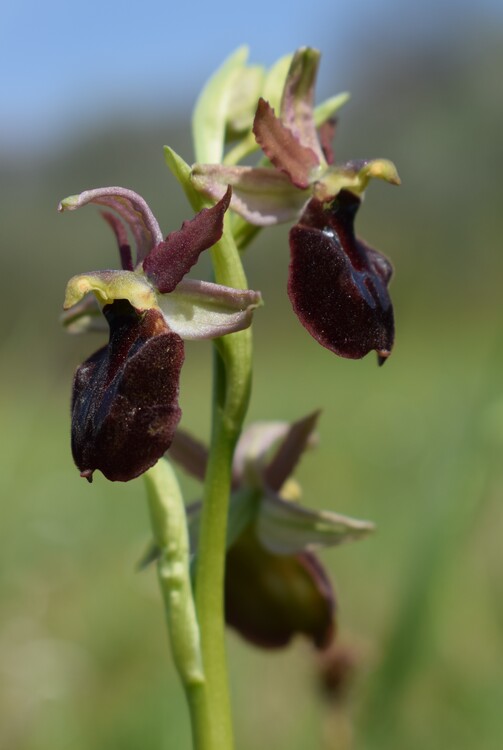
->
[72,300,184,481]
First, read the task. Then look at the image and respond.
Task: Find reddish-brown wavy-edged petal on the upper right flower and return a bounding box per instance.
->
[253,98,319,189]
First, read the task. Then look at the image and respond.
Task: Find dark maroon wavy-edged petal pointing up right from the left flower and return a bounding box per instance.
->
[143,187,232,294]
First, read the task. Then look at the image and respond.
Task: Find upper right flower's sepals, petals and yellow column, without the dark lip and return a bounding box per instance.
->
[191,47,400,226]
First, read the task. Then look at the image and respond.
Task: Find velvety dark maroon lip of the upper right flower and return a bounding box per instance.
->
[288,190,394,363]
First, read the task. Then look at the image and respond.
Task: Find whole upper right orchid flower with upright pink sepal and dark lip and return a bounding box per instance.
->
[191,48,400,364]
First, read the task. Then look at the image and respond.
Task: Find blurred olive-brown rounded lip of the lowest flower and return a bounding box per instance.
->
[225,528,335,648]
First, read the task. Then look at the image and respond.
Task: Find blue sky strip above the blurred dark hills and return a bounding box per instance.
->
[0,0,503,150]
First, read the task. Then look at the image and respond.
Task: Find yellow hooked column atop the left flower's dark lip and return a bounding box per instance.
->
[63,271,158,310]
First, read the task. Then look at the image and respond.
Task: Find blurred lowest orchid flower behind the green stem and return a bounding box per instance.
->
[170,413,373,648]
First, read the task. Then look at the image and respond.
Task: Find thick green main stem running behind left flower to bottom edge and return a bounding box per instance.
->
[196,216,251,750]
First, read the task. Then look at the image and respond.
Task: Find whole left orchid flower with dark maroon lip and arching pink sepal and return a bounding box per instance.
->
[59,187,260,481]
